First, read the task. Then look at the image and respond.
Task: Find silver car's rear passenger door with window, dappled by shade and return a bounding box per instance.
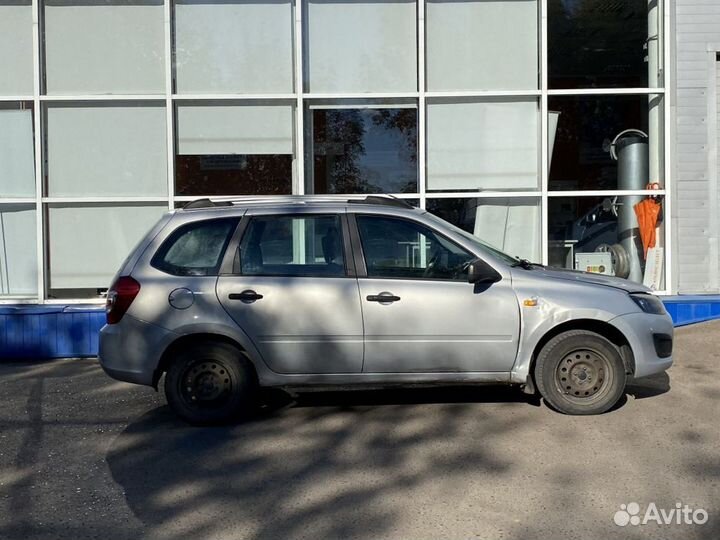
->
[212,211,363,373]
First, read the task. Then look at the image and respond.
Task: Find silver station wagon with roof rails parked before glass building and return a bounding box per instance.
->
[99,196,673,424]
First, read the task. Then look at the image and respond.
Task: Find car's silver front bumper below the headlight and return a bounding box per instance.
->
[610,313,673,379]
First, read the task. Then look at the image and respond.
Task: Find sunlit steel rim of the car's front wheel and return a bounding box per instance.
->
[555,348,613,403]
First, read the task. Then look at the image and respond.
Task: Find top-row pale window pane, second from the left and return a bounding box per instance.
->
[45,0,165,94]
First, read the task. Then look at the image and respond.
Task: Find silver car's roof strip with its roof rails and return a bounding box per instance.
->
[182,195,414,211]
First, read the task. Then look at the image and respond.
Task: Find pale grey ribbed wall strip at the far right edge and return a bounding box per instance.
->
[675,0,720,293]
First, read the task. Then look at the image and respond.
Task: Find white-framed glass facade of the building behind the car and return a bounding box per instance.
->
[0,0,669,302]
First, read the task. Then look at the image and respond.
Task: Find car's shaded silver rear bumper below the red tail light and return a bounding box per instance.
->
[98,314,177,385]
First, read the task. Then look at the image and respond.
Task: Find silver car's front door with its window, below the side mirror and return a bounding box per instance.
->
[356,215,520,373]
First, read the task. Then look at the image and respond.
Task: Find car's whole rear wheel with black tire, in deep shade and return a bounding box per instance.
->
[165,342,257,426]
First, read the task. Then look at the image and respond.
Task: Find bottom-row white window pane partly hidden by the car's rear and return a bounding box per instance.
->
[47,204,167,298]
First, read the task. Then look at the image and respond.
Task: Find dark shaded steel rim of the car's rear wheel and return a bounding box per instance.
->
[178,360,233,409]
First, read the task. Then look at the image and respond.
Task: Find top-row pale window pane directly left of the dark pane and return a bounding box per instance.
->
[425,0,538,91]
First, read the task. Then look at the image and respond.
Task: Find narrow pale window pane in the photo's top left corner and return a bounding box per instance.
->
[0,0,33,96]
